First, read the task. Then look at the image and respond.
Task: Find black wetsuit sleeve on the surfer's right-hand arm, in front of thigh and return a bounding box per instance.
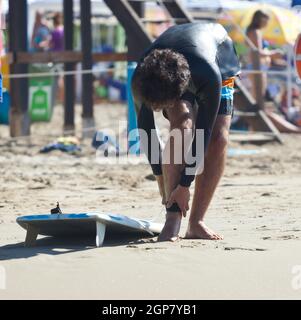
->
[180,69,222,187]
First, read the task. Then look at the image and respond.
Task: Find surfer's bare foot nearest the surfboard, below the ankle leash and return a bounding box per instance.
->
[158,212,182,242]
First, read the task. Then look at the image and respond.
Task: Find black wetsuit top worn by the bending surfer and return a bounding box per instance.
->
[133,22,240,187]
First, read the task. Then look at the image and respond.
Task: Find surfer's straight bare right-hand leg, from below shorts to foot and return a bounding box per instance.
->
[186,115,231,240]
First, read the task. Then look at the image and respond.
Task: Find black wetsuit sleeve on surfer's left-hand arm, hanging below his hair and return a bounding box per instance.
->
[136,104,162,176]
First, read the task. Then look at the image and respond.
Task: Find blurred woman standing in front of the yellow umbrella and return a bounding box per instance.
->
[246,10,283,96]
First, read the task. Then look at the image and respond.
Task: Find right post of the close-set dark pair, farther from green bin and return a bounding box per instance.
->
[80,0,95,136]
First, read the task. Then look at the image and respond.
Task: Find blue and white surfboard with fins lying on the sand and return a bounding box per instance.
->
[17,213,163,247]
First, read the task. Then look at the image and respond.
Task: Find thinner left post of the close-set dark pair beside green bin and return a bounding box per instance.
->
[64,0,75,130]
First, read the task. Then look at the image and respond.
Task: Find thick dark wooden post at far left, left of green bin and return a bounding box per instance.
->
[9,0,30,137]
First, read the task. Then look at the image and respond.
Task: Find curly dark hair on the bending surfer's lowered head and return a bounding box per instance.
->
[133,49,191,109]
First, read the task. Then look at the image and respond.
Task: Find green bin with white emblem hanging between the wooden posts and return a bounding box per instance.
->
[29,64,55,122]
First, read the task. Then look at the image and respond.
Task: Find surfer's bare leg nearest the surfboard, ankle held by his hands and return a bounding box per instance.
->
[158,101,194,241]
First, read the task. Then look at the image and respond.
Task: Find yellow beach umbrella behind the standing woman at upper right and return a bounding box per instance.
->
[219,4,301,46]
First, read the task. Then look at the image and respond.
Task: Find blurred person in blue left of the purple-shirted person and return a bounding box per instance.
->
[31,11,51,52]
